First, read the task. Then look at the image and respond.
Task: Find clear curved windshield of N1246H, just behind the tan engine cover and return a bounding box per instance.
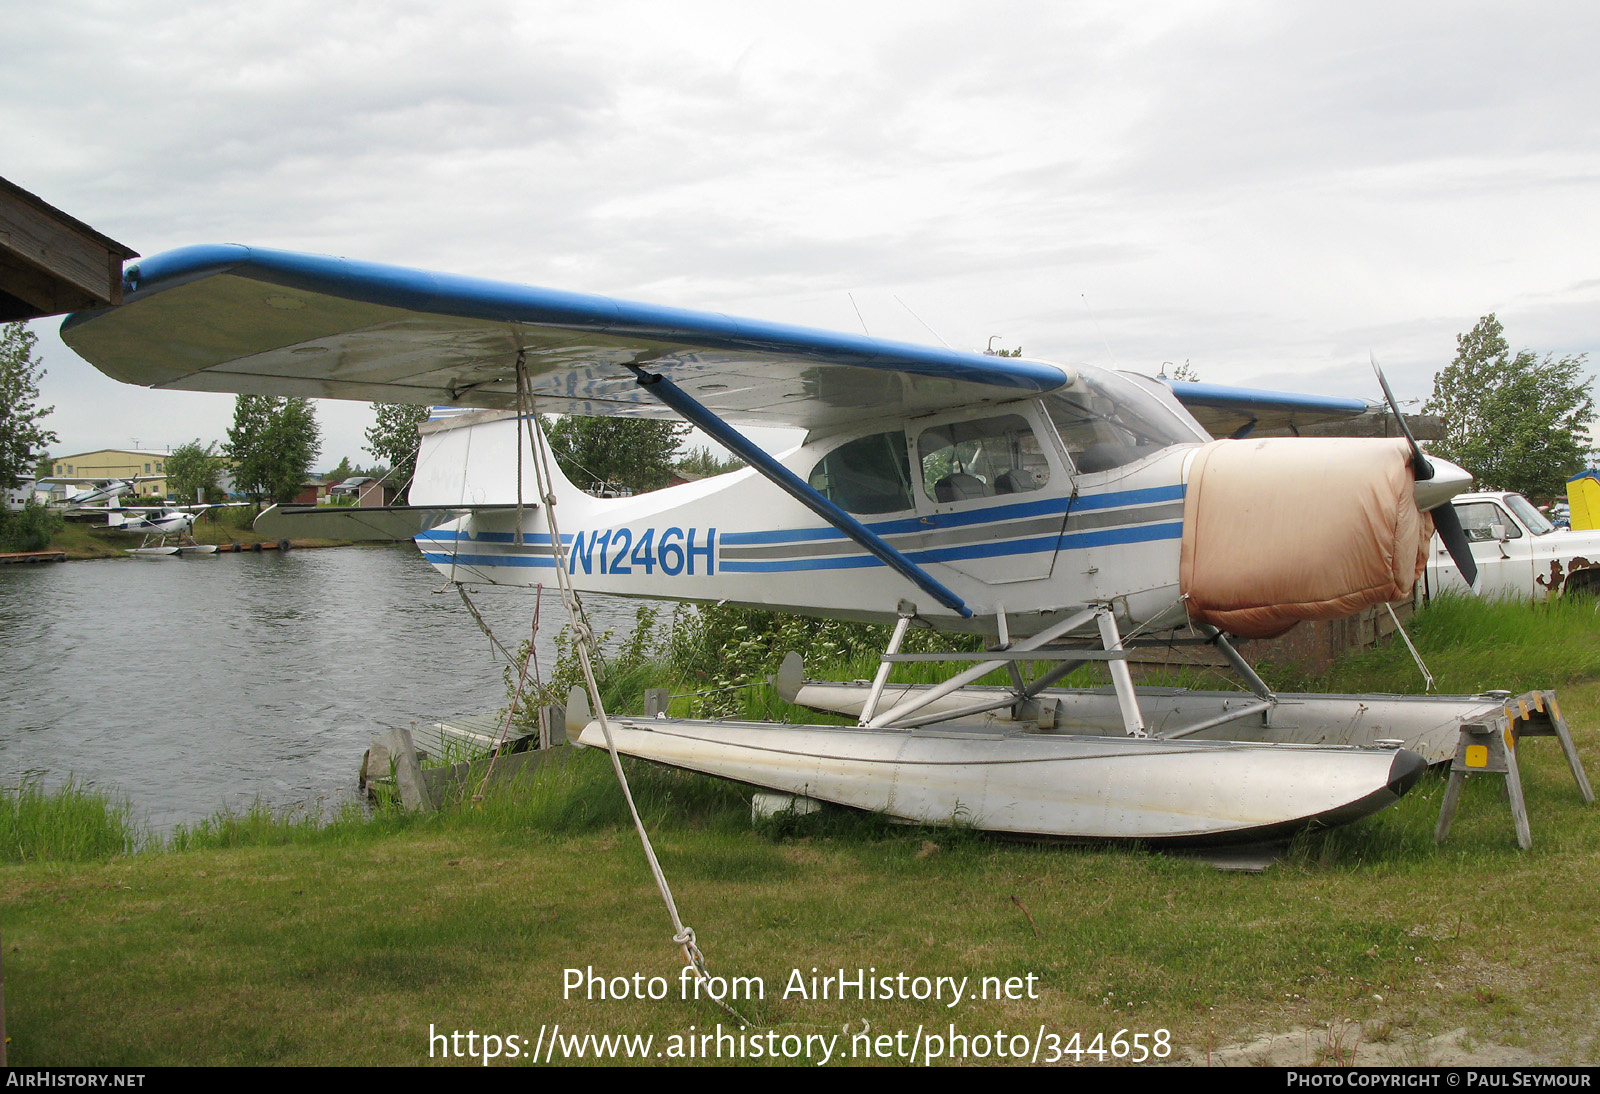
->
[1045,369,1206,475]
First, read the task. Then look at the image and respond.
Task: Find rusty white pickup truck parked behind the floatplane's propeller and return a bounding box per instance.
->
[1426,494,1600,600]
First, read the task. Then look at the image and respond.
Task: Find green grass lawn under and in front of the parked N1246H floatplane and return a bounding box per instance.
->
[0,605,1600,1067]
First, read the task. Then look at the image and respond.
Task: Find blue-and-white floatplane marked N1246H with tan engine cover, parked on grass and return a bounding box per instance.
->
[62,245,1502,843]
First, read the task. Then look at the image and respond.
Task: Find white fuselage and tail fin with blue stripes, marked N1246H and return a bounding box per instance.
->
[411,390,1203,633]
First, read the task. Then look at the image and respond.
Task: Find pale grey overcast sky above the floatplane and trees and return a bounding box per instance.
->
[0,0,1600,467]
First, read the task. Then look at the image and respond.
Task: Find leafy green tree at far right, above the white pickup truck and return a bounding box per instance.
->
[1422,313,1595,497]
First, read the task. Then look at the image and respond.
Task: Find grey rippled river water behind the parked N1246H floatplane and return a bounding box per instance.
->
[0,544,649,830]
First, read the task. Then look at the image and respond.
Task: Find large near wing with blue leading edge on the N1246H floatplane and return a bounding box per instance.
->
[61,245,1069,429]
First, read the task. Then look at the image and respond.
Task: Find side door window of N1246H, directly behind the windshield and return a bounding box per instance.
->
[917,414,1050,502]
